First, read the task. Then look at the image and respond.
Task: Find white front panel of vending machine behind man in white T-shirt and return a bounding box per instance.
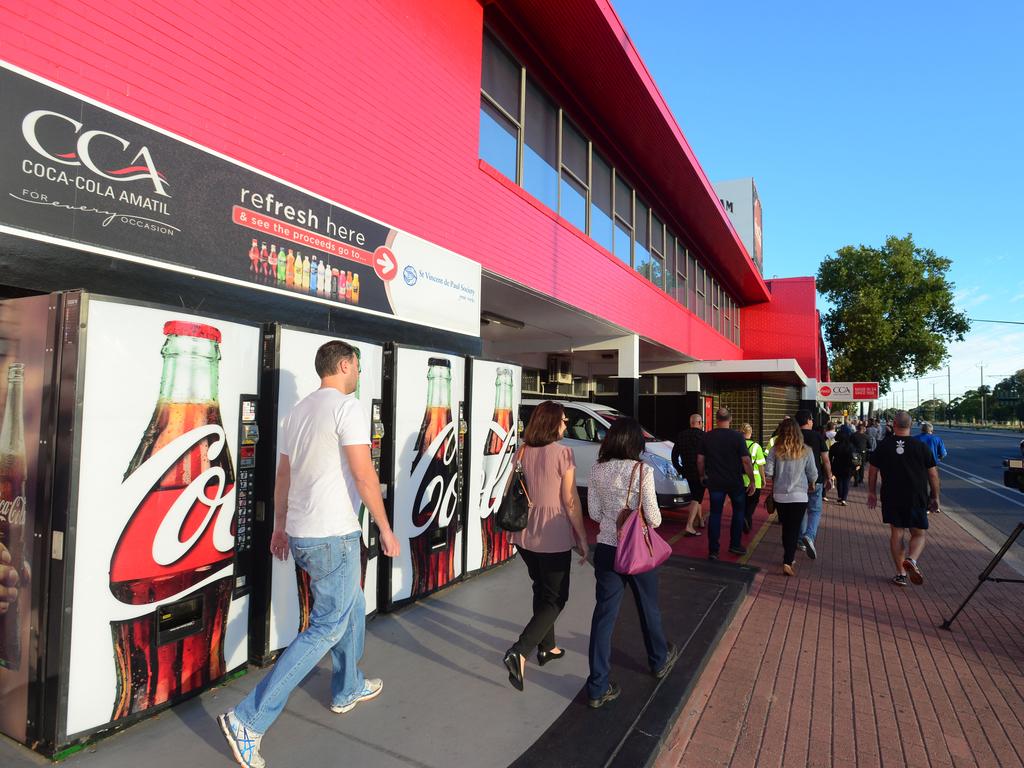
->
[260,328,384,662]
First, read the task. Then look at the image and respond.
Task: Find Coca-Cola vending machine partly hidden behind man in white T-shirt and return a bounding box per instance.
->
[250,325,387,665]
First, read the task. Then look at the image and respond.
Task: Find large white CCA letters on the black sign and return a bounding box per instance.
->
[22,110,171,198]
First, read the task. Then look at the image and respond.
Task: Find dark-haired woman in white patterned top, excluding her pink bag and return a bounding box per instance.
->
[587,419,679,709]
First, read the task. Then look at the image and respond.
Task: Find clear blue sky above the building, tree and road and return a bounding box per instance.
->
[611,0,1024,406]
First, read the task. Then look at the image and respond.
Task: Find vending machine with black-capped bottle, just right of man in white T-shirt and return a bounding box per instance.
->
[380,344,467,610]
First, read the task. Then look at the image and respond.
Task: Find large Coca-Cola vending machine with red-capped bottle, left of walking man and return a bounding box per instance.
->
[3,292,260,754]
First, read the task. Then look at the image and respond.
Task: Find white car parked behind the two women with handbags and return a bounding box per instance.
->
[519,399,690,508]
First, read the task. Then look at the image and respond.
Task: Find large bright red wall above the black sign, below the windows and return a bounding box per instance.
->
[0,0,750,359]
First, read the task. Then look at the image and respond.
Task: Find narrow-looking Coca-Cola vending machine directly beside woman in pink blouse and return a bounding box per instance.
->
[465,357,522,575]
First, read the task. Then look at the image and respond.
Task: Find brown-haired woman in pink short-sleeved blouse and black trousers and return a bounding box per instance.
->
[504,400,587,690]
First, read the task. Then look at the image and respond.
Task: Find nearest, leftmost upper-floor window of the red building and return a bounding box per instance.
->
[480,35,522,181]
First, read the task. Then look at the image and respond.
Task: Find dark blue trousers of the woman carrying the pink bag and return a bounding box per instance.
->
[587,544,669,698]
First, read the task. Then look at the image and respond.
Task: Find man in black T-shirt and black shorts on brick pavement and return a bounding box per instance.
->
[867,411,939,587]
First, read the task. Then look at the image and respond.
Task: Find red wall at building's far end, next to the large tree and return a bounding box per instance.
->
[739,278,821,381]
